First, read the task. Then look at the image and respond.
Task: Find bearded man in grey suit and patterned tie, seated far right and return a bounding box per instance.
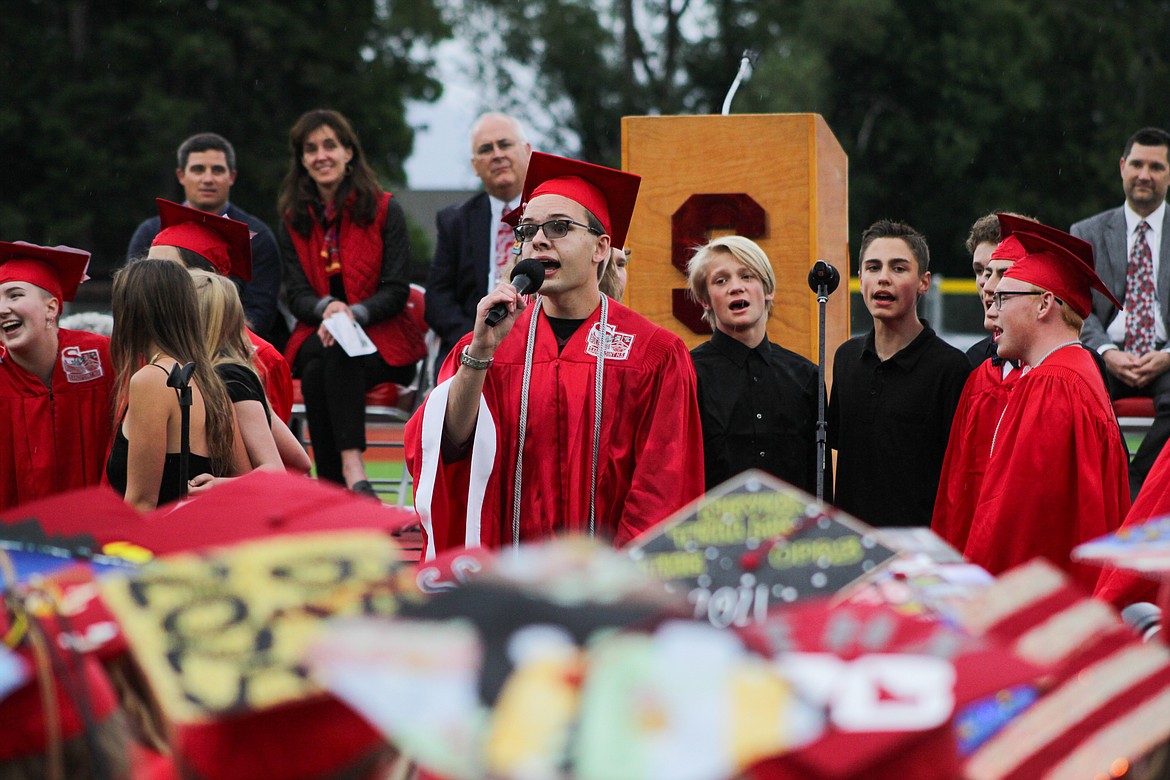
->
[1071,127,1170,496]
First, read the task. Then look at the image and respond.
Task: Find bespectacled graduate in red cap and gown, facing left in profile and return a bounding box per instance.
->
[963,226,1129,589]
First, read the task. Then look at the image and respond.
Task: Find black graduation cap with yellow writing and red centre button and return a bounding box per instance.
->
[627,470,895,627]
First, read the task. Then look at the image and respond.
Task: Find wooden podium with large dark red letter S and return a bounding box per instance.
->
[621,113,849,377]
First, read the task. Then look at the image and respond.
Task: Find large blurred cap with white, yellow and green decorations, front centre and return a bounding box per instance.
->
[309,538,821,780]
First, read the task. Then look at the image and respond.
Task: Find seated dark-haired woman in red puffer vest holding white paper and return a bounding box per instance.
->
[278,109,426,496]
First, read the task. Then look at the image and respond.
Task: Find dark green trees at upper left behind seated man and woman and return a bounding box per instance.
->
[0,0,450,275]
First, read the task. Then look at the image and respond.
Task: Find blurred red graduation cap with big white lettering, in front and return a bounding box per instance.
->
[743,599,1041,780]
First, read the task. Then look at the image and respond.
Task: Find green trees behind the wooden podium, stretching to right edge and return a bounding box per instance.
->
[441,0,1170,276]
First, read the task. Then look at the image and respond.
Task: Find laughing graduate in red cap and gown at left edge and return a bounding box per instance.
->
[0,242,113,510]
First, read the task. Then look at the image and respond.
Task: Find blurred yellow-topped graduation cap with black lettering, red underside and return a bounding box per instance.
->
[101,531,415,780]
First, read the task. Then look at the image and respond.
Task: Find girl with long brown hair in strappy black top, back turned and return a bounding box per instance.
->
[105,260,249,511]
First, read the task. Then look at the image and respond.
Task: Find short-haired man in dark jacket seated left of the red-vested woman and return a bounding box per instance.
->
[126,132,289,348]
